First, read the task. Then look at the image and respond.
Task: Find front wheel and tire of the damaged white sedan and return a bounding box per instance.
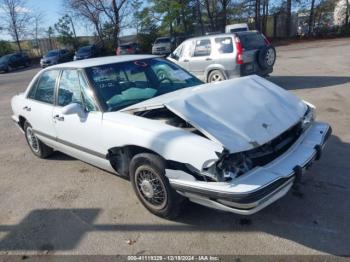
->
[129,153,185,219]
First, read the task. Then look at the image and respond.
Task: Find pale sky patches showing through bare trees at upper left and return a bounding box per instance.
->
[0,0,132,40]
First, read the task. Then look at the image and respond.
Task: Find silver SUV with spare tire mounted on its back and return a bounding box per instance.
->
[168,31,276,82]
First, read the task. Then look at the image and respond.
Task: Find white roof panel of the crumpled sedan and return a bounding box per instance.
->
[48,55,159,69]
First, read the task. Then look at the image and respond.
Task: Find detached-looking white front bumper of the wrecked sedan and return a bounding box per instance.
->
[167,122,332,215]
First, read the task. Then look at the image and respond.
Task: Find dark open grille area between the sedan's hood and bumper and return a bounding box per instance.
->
[245,122,302,167]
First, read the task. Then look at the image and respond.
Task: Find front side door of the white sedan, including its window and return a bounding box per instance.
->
[53,69,108,169]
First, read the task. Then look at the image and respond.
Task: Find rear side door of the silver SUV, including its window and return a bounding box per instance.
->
[189,38,213,81]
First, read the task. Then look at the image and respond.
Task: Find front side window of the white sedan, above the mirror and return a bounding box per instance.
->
[57,70,82,106]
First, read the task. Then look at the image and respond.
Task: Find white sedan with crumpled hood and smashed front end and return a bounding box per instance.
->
[11,55,331,217]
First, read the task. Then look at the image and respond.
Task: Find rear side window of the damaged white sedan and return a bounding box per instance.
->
[34,70,59,104]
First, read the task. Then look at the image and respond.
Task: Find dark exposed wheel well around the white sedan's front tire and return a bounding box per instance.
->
[107,145,163,177]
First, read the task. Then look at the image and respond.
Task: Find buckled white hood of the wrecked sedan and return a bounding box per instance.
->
[123,76,307,153]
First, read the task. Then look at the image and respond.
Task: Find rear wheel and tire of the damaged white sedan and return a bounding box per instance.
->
[23,121,54,158]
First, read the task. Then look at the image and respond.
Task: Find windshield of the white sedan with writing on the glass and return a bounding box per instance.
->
[85,58,202,111]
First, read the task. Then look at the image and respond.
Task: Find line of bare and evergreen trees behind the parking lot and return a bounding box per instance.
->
[0,0,350,54]
